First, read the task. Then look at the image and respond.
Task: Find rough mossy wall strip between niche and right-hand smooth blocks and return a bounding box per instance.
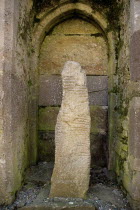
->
[109,1,130,176]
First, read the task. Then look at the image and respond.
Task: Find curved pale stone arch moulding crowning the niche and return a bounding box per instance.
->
[34,3,107,43]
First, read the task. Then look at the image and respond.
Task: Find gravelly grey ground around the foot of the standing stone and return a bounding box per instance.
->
[0,162,131,210]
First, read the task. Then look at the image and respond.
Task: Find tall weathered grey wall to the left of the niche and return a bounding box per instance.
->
[0,0,36,203]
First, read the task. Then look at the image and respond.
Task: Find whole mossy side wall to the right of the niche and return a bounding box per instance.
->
[110,1,140,209]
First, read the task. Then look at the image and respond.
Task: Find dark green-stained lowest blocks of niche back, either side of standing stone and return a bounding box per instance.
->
[38,106,108,167]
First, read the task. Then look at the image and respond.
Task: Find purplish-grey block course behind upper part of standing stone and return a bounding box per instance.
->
[39,75,108,106]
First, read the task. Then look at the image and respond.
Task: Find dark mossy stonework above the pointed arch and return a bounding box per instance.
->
[34,0,123,32]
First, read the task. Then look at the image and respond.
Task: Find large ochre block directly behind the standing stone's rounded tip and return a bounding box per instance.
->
[39,34,108,75]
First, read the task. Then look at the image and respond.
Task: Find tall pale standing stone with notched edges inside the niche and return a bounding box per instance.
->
[50,61,91,198]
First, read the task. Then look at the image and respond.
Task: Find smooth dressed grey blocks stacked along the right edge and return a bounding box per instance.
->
[128,0,140,209]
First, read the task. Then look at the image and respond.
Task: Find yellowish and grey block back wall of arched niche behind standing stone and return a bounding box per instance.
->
[38,17,108,166]
